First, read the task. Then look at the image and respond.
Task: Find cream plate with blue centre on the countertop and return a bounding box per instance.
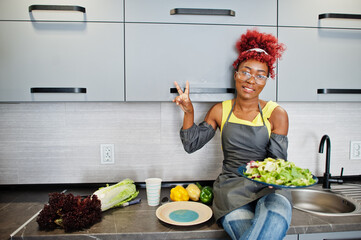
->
[155,201,213,226]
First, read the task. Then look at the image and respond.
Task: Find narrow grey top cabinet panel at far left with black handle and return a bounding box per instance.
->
[0,0,123,22]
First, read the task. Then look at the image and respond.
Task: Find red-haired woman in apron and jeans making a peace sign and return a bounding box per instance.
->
[173,30,292,239]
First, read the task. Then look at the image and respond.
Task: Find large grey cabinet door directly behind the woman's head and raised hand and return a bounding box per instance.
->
[125,23,276,101]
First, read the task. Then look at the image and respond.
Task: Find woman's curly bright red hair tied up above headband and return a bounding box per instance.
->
[233,30,286,78]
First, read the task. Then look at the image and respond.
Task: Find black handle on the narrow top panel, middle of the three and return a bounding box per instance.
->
[170,8,236,17]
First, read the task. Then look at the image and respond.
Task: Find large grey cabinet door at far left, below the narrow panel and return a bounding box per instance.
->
[0,21,124,101]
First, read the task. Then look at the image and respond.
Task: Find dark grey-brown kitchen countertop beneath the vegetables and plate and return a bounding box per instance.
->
[0,184,361,240]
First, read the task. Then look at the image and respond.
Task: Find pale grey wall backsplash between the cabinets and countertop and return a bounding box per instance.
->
[0,102,361,184]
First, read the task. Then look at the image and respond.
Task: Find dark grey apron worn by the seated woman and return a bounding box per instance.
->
[212,101,283,220]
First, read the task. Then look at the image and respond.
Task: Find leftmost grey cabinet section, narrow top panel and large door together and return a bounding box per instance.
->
[0,0,124,102]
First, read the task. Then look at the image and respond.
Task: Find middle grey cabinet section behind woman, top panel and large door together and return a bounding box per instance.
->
[125,0,277,102]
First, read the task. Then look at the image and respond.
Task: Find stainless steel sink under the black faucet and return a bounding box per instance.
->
[292,184,361,216]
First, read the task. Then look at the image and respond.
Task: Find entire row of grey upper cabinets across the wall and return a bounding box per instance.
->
[0,0,361,102]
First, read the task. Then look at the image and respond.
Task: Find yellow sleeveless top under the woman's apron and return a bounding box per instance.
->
[221,99,279,136]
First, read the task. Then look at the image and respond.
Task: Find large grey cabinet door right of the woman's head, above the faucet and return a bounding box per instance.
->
[278,27,361,101]
